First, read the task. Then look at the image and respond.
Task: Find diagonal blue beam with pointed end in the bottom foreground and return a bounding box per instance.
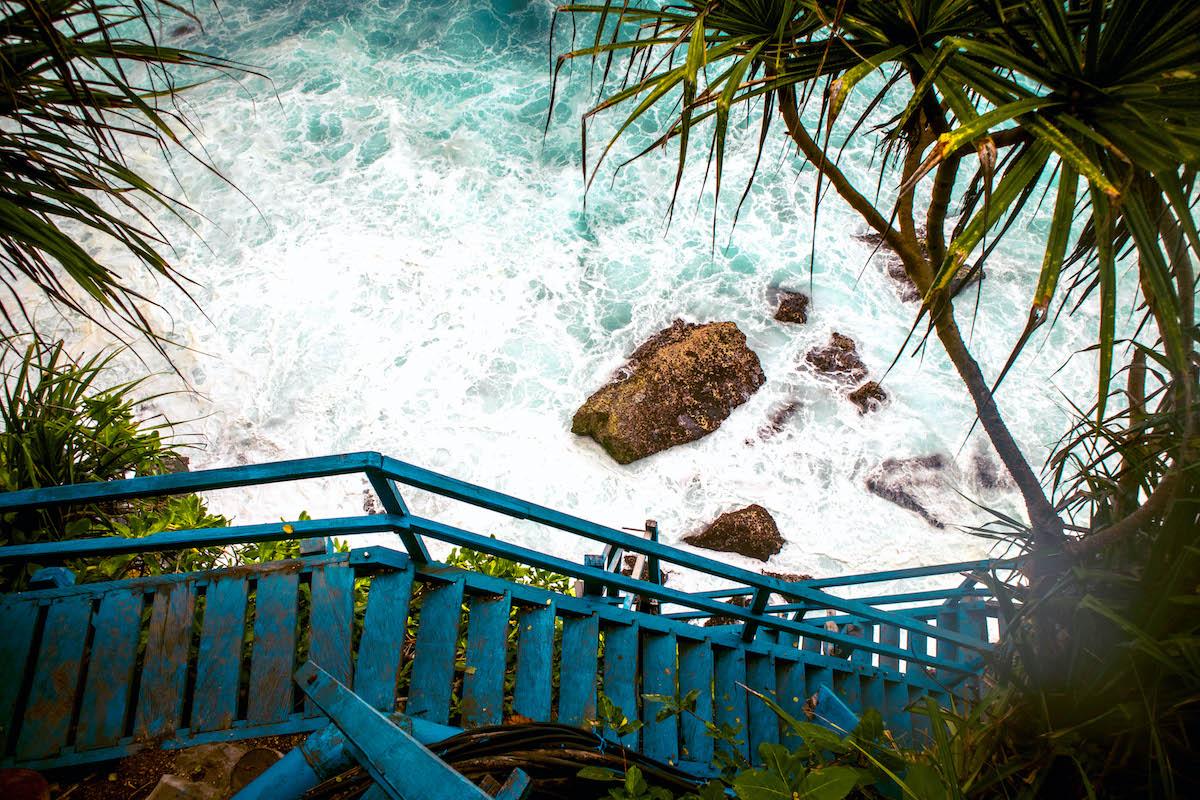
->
[296,661,487,800]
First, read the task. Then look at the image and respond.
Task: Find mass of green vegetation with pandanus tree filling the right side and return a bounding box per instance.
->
[556,0,1200,798]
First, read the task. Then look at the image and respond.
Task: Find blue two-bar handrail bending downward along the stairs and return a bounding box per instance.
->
[0,452,1018,673]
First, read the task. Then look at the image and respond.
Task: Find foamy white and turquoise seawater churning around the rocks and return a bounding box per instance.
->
[28,0,1118,597]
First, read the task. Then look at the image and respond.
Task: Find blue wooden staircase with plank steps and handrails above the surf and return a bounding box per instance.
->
[0,452,1018,775]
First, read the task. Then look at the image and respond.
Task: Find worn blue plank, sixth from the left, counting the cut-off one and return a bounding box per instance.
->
[246,572,300,724]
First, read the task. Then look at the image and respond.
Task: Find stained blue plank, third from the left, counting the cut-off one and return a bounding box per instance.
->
[76,590,144,750]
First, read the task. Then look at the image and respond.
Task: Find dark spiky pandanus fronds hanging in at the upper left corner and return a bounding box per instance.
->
[0,0,238,349]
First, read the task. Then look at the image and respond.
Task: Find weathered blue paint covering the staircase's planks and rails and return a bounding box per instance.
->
[0,453,1019,770]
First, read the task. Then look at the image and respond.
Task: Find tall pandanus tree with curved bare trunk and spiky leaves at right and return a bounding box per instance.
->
[556,0,1200,575]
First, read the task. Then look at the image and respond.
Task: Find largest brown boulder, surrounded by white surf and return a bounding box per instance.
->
[571,319,767,464]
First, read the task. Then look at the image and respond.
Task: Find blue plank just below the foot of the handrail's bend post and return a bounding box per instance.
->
[354,567,413,711]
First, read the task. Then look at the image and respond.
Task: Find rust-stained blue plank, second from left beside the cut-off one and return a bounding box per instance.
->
[17,596,91,760]
